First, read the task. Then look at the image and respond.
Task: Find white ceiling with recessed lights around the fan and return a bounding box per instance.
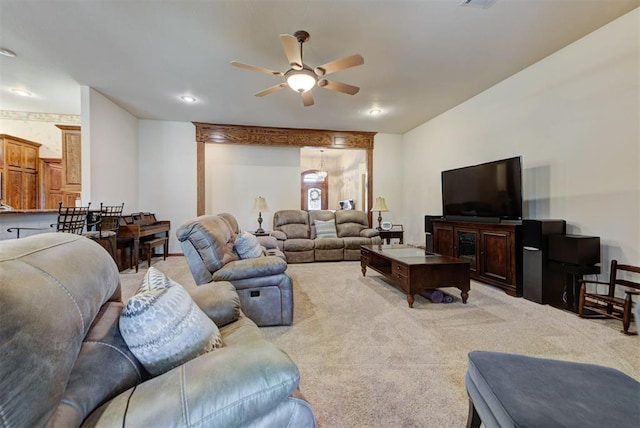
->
[0,0,640,133]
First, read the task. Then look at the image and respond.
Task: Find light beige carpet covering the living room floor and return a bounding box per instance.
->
[121,257,640,427]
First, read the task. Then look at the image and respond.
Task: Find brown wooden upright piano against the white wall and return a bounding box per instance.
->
[118,212,171,272]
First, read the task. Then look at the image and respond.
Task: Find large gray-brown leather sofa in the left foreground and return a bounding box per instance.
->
[0,233,315,427]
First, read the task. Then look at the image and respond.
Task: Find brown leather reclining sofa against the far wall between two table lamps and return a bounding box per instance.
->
[271,210,382,263]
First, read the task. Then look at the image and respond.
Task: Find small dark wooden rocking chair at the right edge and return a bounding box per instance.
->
[578,260,640,334]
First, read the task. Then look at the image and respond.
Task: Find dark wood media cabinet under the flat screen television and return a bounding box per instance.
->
[432,220,522,297]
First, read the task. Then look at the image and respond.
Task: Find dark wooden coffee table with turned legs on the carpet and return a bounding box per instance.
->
[360,245,471,308]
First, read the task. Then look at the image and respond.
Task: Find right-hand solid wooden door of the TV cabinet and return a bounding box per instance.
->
[480,230,513,283]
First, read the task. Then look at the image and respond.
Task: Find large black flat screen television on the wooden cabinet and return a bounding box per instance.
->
[442,156,522,220]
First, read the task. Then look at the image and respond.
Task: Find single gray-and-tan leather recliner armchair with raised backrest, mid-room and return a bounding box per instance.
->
[176,214,293,326]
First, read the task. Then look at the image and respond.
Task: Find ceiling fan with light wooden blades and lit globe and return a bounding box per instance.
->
[231,30,364,107]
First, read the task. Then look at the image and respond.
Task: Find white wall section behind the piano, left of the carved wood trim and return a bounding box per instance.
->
[138,120,197,253]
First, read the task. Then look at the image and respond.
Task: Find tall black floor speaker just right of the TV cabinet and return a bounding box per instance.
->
[522,220,567,307]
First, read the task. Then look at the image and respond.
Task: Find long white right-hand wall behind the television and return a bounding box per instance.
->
[402,9,640,271]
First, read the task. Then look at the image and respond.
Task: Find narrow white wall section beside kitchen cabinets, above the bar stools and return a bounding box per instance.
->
[81,86,138,213]
